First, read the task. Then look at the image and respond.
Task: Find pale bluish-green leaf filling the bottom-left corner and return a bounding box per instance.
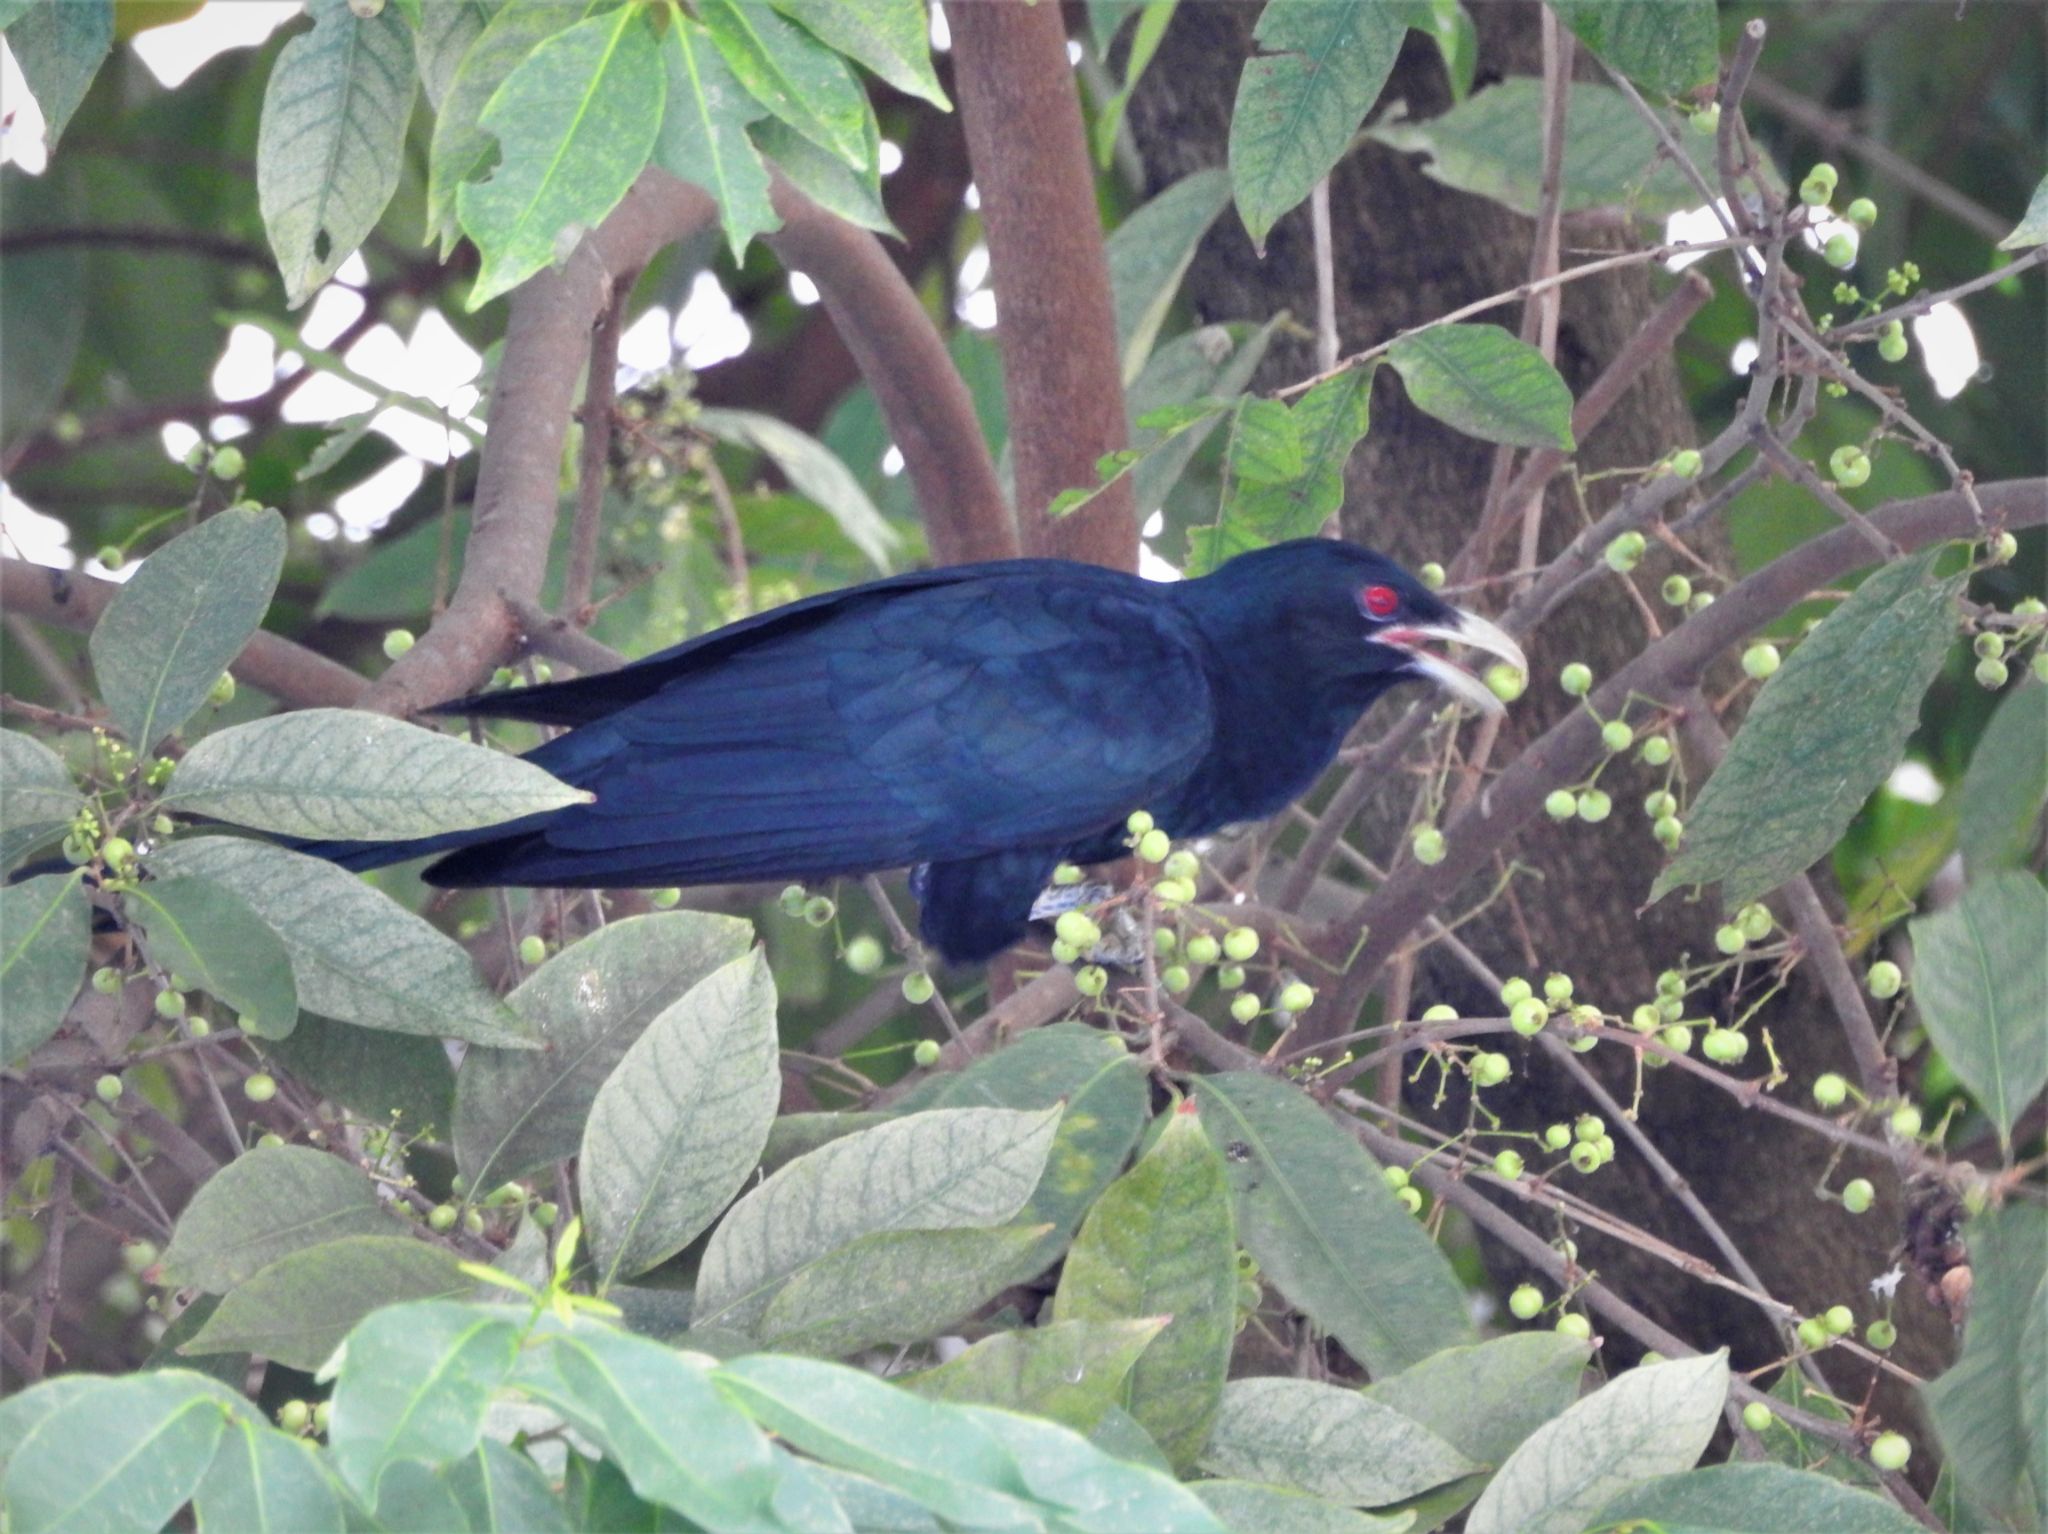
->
[0,1368,236,1534]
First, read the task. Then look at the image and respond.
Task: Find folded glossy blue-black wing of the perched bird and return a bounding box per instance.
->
[432,567,1210,885]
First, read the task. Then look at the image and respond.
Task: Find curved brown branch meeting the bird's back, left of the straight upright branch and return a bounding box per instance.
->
[768,176,1018,565]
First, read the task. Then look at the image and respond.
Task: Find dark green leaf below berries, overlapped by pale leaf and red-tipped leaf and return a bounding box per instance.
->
[903,1022,1151,1261]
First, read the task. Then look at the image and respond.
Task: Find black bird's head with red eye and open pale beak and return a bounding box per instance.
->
[1194,539,1528,713]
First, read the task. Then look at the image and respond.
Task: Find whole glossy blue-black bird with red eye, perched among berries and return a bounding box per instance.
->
[301,539,1524,963]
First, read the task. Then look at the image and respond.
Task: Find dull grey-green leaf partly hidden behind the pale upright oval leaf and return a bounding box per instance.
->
[455,911,754,1188]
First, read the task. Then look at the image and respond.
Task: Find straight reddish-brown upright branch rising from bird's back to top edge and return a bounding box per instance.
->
[946,4,1139,569]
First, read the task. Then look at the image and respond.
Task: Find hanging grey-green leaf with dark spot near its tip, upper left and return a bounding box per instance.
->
[256,0,418,309]
